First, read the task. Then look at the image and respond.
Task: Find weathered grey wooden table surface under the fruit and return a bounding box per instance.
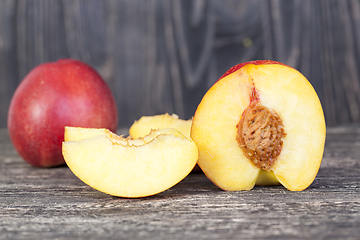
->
[0,126,360,239]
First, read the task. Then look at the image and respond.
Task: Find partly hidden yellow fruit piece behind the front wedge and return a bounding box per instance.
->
[129,113,192,138]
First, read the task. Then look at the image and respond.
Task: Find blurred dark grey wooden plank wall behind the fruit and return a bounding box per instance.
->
[0,0,360,127]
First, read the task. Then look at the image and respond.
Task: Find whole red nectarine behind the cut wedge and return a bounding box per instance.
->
[8,59,118,167]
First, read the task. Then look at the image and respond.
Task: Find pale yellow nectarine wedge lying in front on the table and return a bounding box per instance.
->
[63,127,198,198]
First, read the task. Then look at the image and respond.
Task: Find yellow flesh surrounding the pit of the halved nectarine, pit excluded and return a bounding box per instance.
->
[191,64,325,190]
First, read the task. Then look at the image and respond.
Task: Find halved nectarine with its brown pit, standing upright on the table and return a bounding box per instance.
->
[191,61,326,191]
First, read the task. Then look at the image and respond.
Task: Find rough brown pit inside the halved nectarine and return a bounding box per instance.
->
[237,87,286,171]
